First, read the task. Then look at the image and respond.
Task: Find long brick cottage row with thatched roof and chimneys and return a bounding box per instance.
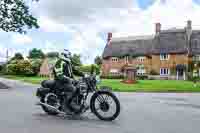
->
[102,21,200,80]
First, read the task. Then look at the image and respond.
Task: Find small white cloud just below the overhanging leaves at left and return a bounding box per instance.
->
[12,34,32,44]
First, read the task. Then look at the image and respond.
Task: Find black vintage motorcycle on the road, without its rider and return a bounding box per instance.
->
[36,75,120,121]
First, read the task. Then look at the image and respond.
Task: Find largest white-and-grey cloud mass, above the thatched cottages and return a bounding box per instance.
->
[30,0,200,63]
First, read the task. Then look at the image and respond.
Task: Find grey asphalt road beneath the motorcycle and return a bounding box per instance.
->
[0,78,200,133]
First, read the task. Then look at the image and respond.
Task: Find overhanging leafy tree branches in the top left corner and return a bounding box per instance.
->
[0,0,39,33]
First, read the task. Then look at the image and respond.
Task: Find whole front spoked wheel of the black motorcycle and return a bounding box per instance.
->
[90,91,120,121]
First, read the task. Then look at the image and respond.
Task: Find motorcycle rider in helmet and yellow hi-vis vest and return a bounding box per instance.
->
[53,50,83,110]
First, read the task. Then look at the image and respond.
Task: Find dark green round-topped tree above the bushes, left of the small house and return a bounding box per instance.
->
[28,48,45,59]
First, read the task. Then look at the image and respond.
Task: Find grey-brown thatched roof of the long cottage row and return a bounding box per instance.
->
[103,29,200,58]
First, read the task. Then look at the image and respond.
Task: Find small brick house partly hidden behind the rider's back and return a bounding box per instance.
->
[39,58,57,77]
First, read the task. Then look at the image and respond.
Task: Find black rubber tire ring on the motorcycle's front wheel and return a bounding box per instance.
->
[90,91,120,121]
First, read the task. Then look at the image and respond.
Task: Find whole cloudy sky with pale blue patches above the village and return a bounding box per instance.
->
[0,0,200,64]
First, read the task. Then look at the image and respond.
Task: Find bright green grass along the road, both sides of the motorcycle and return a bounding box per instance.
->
[3,75,200,92]
